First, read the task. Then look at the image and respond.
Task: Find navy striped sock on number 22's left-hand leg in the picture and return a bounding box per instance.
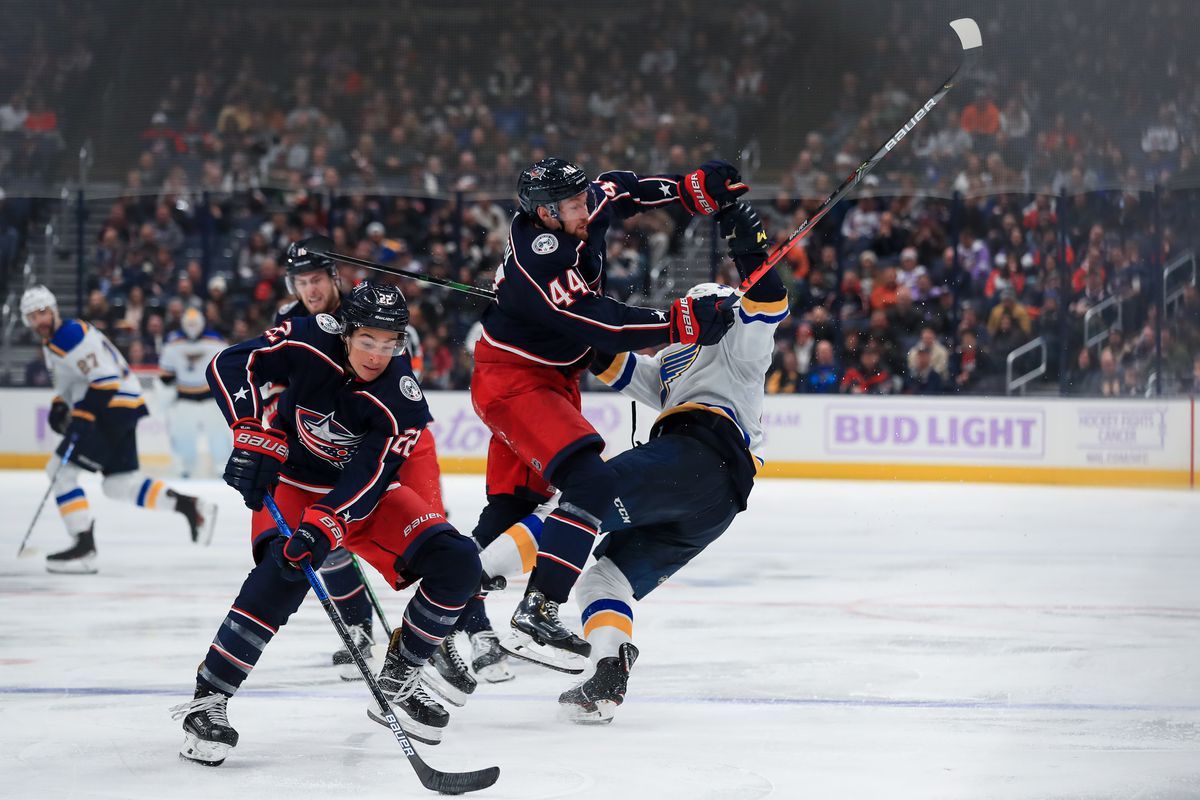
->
[196,559,308,696]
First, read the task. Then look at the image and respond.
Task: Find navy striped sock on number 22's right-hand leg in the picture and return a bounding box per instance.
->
[392,533,480,664]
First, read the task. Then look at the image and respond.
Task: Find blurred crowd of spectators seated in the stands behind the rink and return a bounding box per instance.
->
[0,0,1200,395]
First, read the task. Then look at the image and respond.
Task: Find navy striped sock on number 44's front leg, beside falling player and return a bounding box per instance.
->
[529,449,617,602]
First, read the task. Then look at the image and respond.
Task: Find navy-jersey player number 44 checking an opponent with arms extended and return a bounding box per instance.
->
[470,158,746,672]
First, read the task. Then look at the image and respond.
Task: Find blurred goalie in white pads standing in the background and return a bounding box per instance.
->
[158,308,233,477]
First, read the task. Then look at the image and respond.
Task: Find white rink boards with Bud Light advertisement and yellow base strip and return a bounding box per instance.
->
[0,389,1200,487]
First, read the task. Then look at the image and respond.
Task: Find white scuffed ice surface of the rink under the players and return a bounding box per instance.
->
[0,471,1200,800]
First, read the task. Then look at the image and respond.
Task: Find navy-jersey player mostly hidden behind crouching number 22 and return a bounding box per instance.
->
[268,242,454,680]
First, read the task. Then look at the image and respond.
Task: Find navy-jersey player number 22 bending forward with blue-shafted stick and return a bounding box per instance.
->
[174,281,480,765]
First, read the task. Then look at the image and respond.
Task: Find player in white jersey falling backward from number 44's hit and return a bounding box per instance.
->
[468,203,788,723]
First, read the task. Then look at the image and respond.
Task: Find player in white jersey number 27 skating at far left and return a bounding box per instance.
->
[20,285,216,573]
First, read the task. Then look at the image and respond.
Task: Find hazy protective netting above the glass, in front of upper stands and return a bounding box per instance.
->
[0,0,1200,197]
